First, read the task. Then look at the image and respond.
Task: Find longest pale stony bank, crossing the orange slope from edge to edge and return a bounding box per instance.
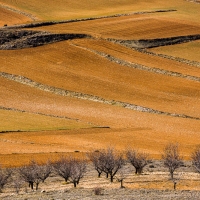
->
[0,72,200,120]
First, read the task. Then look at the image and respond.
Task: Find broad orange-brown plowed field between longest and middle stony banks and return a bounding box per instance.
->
[0,42,200,117]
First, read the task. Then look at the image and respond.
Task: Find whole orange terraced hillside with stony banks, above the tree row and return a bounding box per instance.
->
[0,0,200,172]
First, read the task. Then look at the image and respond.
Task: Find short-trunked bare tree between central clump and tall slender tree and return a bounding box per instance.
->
[126,149,150,174]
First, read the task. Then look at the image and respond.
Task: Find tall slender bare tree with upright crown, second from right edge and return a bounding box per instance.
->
[162,143,183,179]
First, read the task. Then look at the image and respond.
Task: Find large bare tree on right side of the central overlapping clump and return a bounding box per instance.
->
[99,147,125,182]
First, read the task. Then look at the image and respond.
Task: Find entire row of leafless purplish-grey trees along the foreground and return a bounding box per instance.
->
[0,144,200,192]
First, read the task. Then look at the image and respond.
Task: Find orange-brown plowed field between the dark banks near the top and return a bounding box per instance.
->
[31,14,200,40]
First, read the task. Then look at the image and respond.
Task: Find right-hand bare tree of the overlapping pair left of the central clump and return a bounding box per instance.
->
[70,159,86,187]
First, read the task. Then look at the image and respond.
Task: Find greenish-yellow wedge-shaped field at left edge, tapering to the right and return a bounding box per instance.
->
[0,107,92,133]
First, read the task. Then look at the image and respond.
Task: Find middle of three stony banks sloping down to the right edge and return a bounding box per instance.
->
[71,42,200,82]
